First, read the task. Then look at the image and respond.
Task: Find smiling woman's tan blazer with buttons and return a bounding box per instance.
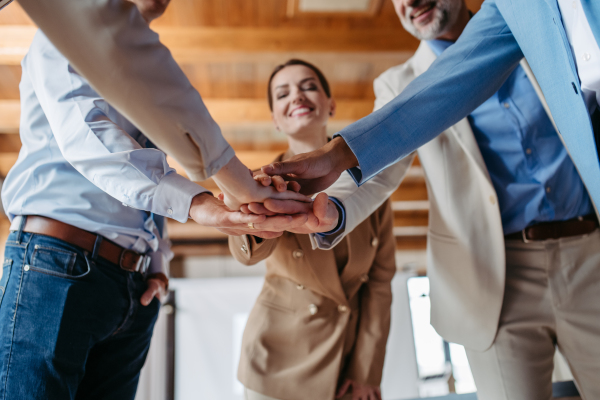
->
[229,201,396,400]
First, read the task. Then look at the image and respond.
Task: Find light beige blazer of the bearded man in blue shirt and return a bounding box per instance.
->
[322,42,592,350]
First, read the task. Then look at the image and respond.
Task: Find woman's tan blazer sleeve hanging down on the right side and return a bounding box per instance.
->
[346,201,396,386]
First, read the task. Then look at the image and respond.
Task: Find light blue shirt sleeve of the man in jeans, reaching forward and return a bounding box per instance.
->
[23,32,206,222]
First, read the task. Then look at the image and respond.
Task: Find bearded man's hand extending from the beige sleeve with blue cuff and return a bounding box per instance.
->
[241,193,340,233]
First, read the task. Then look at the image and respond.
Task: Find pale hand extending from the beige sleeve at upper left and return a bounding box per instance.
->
[213,157,312,210]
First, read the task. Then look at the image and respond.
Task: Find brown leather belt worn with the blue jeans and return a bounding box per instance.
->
[15,215,150,275]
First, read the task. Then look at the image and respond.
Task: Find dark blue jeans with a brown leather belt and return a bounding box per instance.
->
[0,227,160,400]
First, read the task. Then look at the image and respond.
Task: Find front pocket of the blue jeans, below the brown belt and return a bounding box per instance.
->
[30,244,90,279]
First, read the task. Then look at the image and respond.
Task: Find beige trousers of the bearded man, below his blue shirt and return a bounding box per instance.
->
[467,230,600,400]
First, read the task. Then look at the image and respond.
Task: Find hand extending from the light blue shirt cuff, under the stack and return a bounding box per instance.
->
[190,193,308,239]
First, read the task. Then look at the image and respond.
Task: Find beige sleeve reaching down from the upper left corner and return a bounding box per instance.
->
[19,0,235,181]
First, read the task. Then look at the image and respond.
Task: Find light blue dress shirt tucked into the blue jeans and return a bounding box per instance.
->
[2,31,206,274]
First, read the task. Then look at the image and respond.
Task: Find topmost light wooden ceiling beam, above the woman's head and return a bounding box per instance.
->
[0,25,418,65]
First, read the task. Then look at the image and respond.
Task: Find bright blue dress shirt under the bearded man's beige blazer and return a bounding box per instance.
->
[427,40,593,234]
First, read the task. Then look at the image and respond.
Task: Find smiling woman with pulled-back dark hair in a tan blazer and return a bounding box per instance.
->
[229,60,396,400]
